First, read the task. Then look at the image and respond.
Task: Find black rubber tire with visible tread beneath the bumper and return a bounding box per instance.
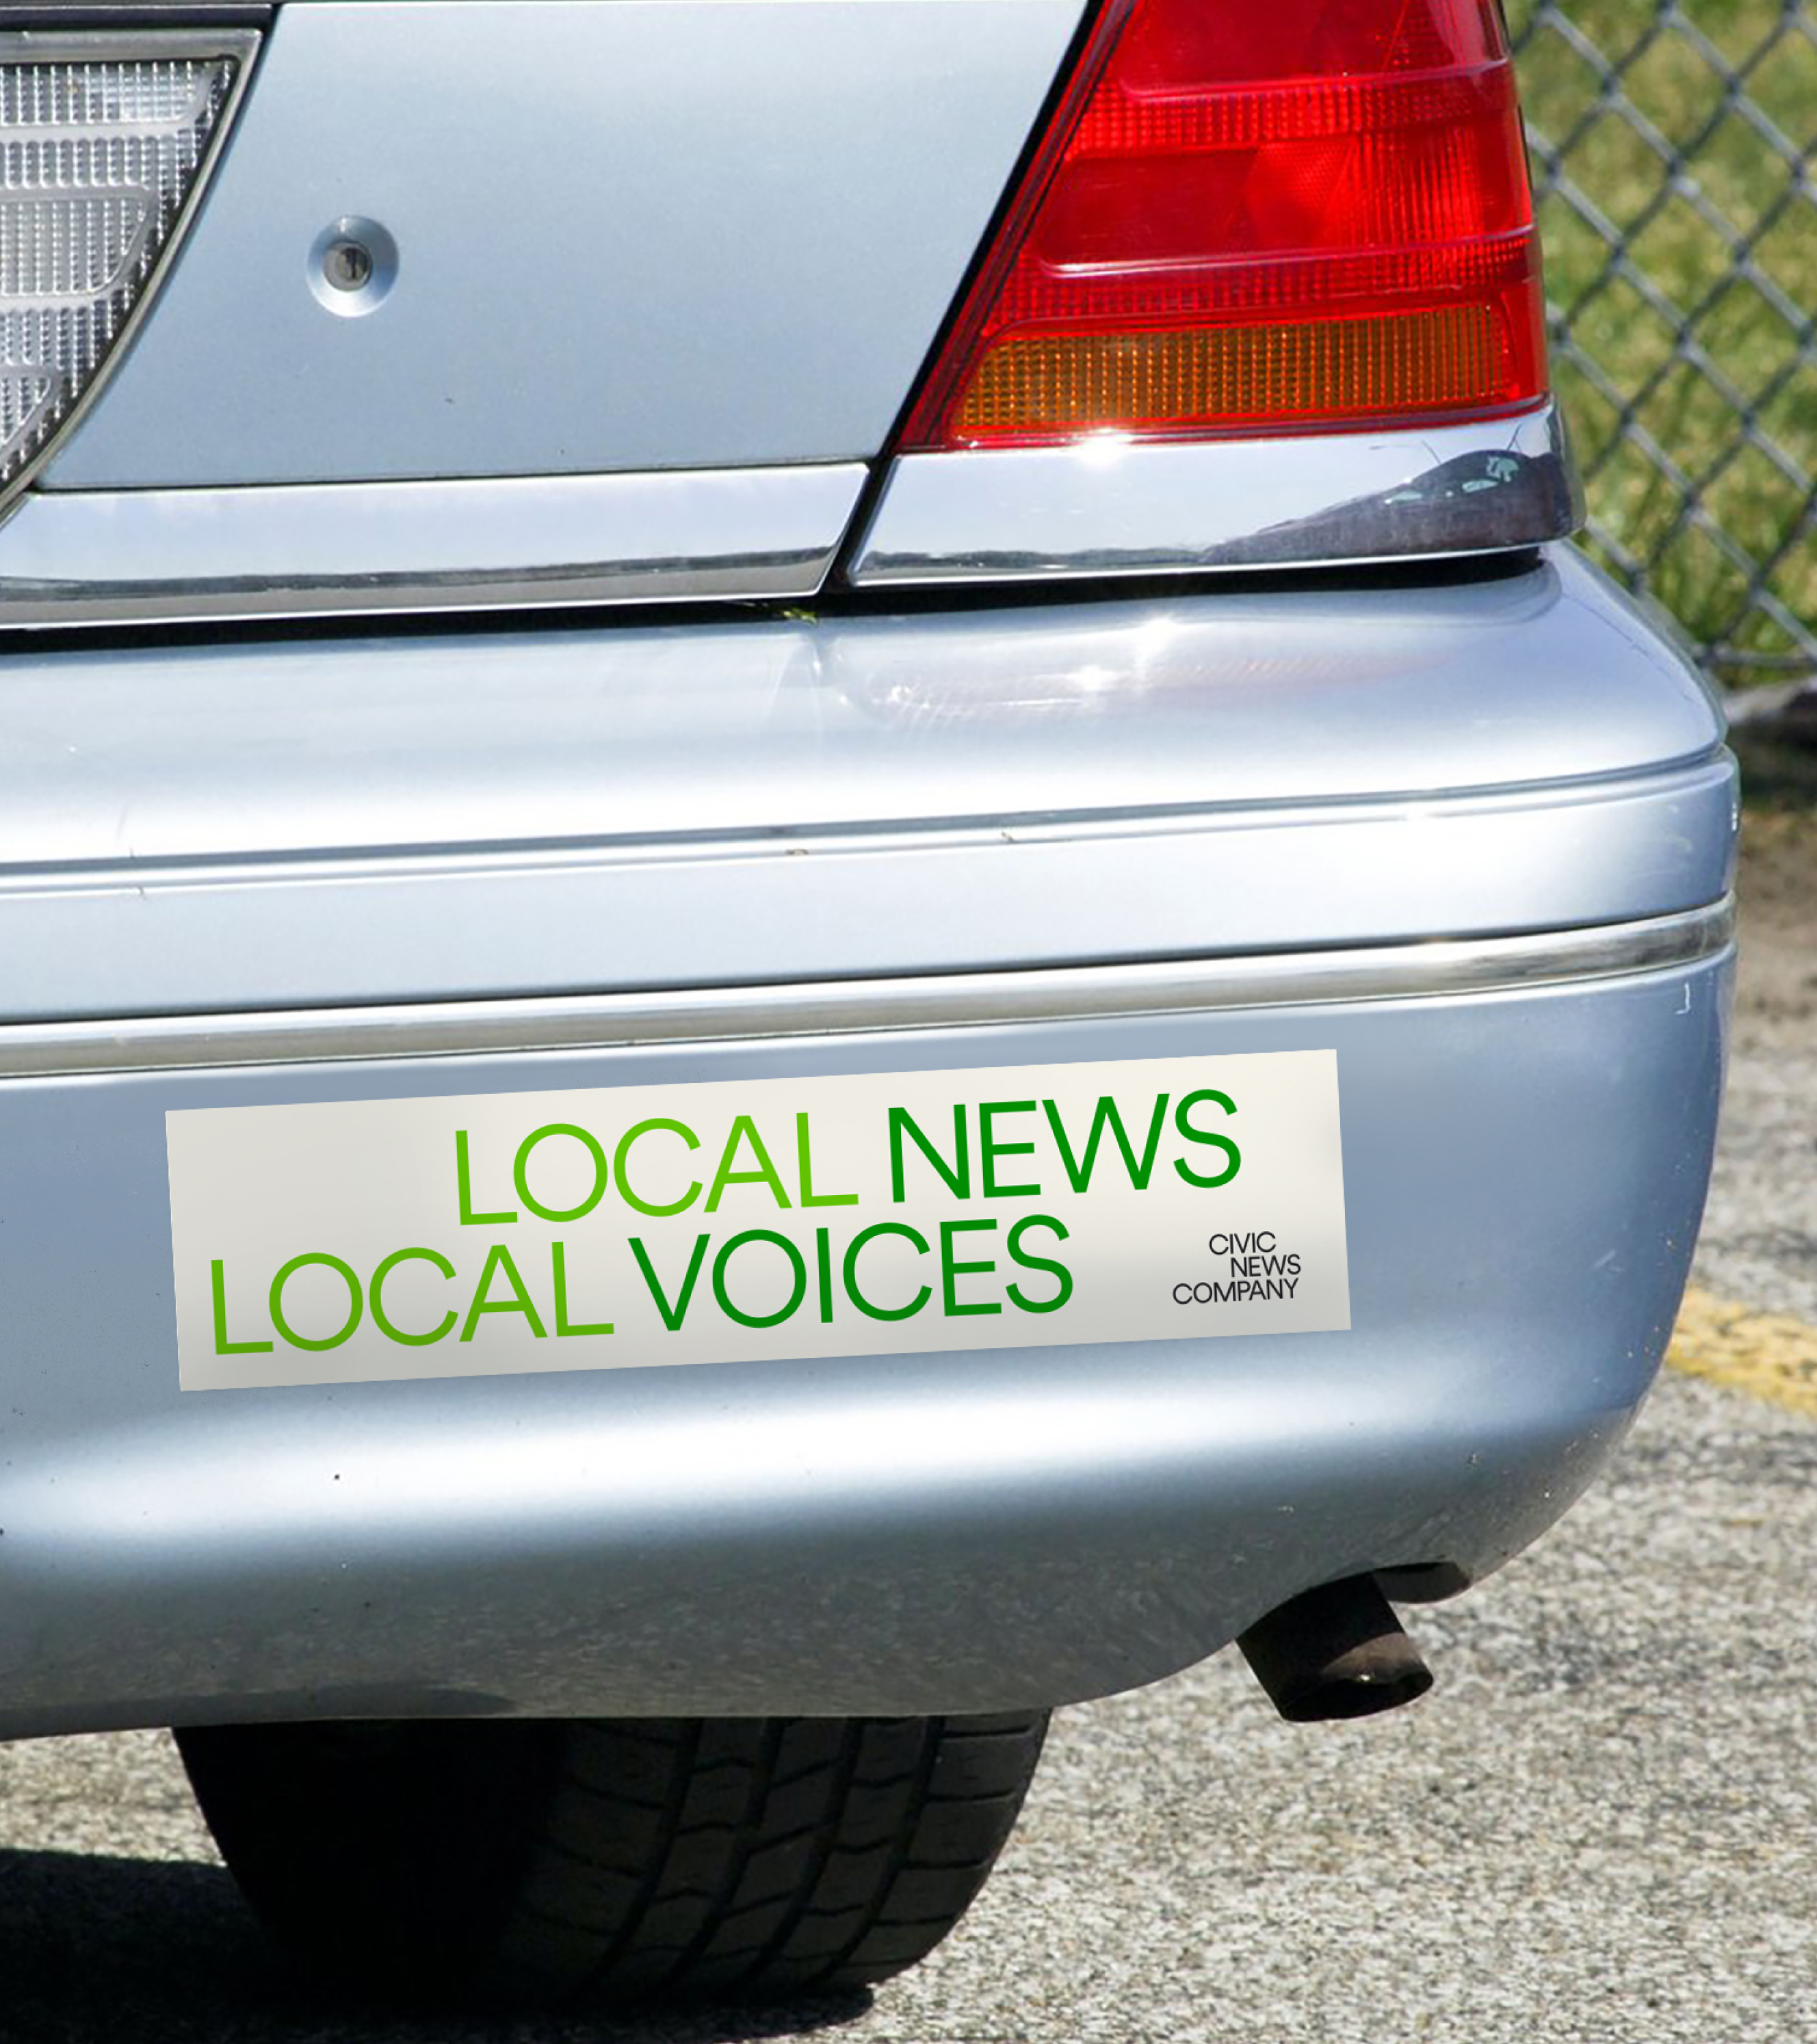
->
[176,1713,1047,2005]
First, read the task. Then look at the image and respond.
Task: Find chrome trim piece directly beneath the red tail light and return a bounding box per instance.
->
[846,401,1582,587]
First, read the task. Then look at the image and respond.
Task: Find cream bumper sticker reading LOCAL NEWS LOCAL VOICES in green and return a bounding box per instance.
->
[166,1051,1349,1390]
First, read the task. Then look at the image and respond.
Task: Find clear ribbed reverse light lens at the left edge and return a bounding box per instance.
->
[0,35,251,499]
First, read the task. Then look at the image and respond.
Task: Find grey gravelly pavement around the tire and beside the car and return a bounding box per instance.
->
[0,744,1817,2044]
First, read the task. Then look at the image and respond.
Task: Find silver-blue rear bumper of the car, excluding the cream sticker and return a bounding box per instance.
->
[0,564,1734,1731]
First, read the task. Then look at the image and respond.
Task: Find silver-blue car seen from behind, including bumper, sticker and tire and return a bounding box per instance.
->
[0,0,1735,2001]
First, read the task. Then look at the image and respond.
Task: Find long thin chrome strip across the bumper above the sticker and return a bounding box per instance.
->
[0,897,1735,1079]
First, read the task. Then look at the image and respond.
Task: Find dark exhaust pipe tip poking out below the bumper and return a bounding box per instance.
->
[1237,1576,1433,1725]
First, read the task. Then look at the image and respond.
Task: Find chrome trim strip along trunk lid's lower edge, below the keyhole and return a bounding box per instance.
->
[0,462,867,627]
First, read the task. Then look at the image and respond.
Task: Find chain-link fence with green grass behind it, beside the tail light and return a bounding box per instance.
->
[1508,0,1817,683]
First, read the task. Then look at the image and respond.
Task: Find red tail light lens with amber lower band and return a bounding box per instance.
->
[902,0,1545,447]
